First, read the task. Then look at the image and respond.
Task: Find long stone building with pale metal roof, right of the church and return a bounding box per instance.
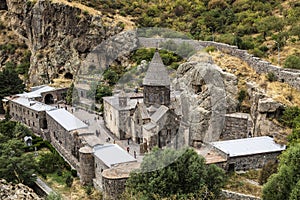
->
[209,136,286,171]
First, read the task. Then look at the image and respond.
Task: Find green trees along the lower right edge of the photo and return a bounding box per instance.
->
[263,107,300,200]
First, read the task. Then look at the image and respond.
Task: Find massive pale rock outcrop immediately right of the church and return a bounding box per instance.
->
[173,54,237,145]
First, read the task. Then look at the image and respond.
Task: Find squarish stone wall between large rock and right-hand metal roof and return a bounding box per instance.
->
[220,113,253,140]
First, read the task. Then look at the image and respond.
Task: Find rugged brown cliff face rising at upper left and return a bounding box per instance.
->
[1,0,129,85]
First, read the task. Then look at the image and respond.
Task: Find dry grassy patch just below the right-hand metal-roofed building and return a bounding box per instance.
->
[225,170,262,197]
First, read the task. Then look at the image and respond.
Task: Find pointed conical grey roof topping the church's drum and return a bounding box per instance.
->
[143,51,170,86]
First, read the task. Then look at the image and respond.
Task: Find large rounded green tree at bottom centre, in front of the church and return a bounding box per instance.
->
[123,148,225,199]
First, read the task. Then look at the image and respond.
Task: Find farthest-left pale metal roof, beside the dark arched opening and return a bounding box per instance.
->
[11,97,56,111]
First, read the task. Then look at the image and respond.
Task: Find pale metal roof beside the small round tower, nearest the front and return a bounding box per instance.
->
[94,144,136,167]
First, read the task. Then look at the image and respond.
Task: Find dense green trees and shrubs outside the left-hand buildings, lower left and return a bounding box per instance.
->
[0,120,77,186]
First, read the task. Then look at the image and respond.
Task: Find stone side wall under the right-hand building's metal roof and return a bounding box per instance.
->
[226,152,280,171]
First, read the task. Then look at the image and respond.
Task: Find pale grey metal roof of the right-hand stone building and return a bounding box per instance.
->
[210,136,285,157]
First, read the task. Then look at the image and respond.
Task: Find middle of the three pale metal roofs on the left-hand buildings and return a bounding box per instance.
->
[47,109,88,131]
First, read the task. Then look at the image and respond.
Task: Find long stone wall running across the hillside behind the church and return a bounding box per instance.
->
[139,38,300,90]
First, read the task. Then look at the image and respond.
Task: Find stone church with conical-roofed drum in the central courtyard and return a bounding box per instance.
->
[103,51,180,151]
